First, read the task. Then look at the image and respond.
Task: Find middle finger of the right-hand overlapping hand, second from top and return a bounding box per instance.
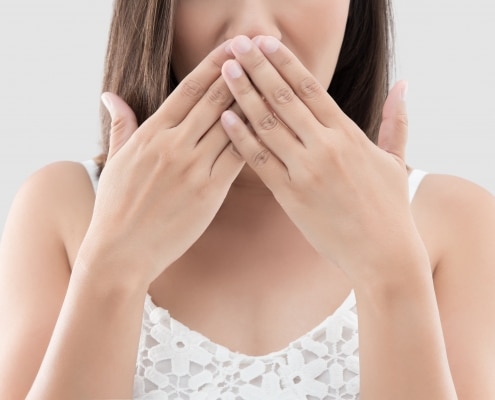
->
[231,36,318,145]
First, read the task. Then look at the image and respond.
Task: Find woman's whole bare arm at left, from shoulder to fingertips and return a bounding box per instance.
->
[0,41,244,400]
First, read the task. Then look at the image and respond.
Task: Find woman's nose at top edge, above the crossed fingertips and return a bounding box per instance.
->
[225,0,282,40]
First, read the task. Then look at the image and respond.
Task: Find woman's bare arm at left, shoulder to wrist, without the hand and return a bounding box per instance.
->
[0,163,149,399]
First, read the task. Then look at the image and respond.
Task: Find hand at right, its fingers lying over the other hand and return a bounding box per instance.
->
[222,36,425,283]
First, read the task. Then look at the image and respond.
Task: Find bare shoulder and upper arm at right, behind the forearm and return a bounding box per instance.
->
[413,175,495,399]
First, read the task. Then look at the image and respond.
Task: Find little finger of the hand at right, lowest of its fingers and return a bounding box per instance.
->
[221,110,290,189]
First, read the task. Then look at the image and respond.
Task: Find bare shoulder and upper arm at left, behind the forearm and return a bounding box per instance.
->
[0,165,72,399]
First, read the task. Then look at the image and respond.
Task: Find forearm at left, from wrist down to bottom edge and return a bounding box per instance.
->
[27,258,146,400]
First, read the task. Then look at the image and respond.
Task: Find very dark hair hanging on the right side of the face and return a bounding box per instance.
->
[328,0,394,143]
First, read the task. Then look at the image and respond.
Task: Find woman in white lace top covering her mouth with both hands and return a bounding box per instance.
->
[0,0,495,400]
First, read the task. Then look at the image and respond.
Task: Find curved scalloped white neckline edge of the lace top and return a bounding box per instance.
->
[145,289,357,361]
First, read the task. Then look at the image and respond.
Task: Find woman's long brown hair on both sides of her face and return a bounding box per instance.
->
[99,0,393,166]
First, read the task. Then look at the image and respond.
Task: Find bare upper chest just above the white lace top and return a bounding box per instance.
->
[149,250,352,356]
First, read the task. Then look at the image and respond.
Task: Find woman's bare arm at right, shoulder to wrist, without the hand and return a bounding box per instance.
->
[356,175,495,400]
